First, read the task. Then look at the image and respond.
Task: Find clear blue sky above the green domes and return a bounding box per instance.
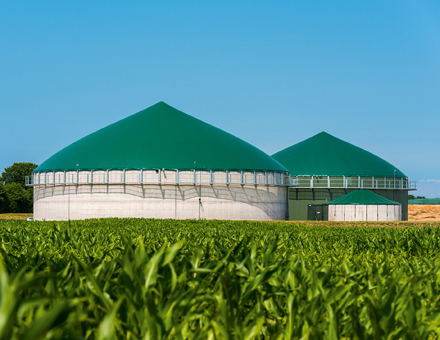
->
[0,0,440,197]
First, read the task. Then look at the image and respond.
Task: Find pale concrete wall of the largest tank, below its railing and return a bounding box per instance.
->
[34,184,287,221]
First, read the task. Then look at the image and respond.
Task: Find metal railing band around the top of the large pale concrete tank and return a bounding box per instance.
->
[25,169,290,186]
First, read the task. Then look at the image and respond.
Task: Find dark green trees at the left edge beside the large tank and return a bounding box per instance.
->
[0,162,38,213]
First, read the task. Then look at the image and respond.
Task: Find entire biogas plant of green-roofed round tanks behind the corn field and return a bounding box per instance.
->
[26,102,415,221]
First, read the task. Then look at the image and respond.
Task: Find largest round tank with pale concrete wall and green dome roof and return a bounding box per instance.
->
[28,102,289,220]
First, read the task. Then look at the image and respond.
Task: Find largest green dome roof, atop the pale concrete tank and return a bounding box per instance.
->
[34,102,287,172]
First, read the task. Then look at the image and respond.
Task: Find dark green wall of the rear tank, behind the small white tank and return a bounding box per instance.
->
[289,188,408,221]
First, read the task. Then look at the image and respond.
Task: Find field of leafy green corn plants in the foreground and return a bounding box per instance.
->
[0,219,440,340]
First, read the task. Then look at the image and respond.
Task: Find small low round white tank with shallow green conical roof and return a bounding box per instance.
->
[324,190,402,221]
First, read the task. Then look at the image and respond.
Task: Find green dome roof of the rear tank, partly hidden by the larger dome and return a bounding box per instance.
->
[272,132,407,178]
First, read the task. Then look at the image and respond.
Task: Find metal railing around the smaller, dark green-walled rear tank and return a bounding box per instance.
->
[290,176,417,190]
